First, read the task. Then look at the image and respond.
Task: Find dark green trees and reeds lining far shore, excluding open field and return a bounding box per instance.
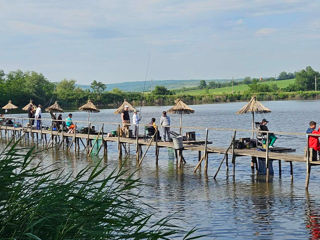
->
[0,66,320,109]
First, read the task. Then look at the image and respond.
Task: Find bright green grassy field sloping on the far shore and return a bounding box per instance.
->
[177,79,295,96]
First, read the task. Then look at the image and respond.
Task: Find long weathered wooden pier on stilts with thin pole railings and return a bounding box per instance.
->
[0,118,320,189]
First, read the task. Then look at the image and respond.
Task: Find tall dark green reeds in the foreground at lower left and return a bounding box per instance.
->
[0,140,201,240]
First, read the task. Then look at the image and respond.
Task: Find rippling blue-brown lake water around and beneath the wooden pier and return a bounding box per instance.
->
[0,101,320,239]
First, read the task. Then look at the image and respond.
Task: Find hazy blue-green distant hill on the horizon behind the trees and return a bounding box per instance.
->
[77,79,237,92]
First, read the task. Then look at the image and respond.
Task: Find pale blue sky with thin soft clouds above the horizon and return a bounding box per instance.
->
[0,0,320,84]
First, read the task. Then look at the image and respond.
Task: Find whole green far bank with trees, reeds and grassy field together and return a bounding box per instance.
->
[0,66,320,109]
